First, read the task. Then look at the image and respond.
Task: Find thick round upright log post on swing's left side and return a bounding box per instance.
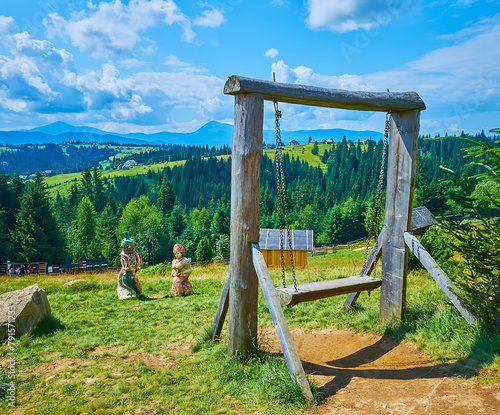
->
[228,93,264,357]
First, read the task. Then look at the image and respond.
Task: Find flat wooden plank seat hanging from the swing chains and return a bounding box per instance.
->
[276,276,382,306]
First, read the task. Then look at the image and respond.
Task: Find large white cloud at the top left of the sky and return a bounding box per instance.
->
[44,0,195,59]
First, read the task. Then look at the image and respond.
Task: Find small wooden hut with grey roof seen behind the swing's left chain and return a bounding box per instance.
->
[259,229,313,268]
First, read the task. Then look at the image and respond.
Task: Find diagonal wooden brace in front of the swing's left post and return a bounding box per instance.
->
[252,244,313,401]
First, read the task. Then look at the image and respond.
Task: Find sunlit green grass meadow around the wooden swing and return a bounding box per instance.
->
[0,250,500,414]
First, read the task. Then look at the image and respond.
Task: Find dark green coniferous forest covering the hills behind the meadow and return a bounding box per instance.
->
[0,134,495,265]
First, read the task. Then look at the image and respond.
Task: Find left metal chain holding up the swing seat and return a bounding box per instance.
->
[273,99,298,291]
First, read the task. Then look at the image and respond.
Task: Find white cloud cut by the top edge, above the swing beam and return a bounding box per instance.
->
[306,0,420,33]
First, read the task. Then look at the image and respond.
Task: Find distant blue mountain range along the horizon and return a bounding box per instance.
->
[0,121,383,147]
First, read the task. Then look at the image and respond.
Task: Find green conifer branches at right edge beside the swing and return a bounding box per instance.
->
[441,138,500,330]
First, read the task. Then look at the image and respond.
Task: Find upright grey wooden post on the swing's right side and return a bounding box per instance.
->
[380,110,420,321]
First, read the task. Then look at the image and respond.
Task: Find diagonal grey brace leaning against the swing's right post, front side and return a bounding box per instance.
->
[404,232,477,324]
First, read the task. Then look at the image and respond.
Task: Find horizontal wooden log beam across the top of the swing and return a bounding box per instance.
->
[224,75,425,112]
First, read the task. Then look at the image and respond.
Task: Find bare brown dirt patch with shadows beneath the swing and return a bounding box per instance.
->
[263,329,500,415]
